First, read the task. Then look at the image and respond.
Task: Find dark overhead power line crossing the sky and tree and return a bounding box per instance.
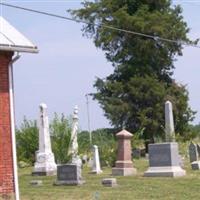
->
[0,3,200,48]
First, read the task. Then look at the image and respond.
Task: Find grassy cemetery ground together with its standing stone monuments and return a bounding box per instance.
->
[13,101,200,200]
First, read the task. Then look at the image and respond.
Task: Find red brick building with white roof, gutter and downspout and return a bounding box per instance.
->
[0,17,38,200]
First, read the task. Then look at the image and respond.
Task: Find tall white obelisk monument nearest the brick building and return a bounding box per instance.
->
[32,103,57,176]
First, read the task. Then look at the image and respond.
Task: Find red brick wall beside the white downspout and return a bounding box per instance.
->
[0,51,14,194]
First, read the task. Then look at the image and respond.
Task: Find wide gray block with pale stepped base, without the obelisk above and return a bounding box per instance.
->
[144,142,186,177]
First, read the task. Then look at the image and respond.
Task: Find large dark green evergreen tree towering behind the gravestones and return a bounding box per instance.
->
[71,0,193,140]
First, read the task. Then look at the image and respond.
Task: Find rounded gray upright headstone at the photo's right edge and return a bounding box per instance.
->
[189,142,200,170]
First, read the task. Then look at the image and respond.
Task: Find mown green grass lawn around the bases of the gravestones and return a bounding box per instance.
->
[19,159,200,200]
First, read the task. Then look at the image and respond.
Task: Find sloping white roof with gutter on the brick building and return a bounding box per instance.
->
[0,16,38,53]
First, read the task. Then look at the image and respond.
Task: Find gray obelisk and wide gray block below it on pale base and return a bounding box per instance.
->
[144,101,186,177]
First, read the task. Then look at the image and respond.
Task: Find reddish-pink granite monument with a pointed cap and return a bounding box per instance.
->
[112,130,136,176]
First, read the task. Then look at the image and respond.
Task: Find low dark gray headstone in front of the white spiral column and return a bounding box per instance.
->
[55,164,85,185]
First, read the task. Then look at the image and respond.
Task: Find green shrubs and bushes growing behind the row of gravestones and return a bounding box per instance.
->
[16,114,200,166]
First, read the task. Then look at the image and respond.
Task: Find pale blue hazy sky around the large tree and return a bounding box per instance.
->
[0,0,200,130]
